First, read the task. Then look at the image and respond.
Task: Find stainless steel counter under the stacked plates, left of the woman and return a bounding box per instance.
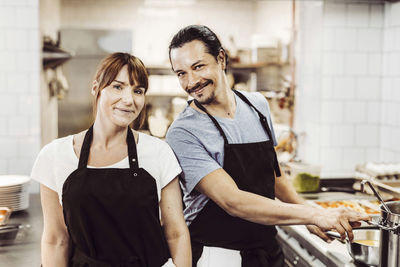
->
[0,194,43,267]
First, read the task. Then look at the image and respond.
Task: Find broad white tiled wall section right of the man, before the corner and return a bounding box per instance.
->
[295,1,384,177]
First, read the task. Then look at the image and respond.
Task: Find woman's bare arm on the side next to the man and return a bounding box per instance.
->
[160,178,192,267]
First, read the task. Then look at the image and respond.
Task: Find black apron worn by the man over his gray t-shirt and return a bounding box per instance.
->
[189,90,284,267]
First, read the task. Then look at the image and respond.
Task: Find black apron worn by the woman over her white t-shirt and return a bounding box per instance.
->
[62,126,170,267]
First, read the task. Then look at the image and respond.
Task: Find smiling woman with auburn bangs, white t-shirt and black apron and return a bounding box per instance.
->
[31,53,191,267]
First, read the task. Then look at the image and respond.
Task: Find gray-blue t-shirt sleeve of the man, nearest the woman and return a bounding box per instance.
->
[167,128,222,194]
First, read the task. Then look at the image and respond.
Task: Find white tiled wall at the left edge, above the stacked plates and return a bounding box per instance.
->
[0,0,40,182]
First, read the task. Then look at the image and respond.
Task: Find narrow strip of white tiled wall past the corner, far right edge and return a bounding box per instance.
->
[380,3,400,162]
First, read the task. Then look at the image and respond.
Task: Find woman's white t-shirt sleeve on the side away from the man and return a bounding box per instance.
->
[31,143,57,192]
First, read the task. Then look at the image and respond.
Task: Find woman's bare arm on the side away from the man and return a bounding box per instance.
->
[40,184,69,267]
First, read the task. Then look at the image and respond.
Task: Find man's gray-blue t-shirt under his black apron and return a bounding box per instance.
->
[166,91,276,225]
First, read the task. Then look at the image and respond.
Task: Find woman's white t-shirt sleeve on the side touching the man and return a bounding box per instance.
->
[159,142,182,188]
